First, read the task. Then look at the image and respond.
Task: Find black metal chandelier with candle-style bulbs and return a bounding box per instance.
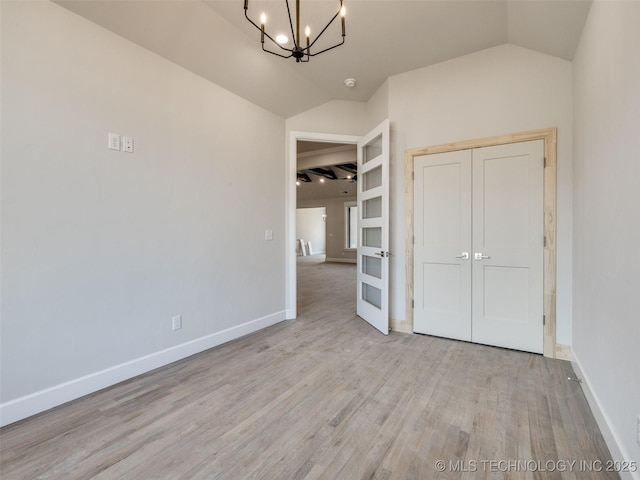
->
[244,0,345,62]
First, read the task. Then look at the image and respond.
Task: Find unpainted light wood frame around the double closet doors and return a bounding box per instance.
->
[402,128,557,358]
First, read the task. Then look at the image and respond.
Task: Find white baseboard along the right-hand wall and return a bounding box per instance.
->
[571,352,640,480]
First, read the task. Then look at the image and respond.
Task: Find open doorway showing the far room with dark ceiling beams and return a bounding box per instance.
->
[295,139,357,313]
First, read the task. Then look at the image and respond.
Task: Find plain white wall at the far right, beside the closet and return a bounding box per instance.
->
[573,1,640,472]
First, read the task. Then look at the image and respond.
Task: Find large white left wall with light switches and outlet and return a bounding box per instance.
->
[0,1,285,423]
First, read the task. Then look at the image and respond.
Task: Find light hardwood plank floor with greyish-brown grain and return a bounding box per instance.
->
[0,257,619,480]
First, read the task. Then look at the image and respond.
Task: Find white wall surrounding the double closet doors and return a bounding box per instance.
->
[389,45,572,345]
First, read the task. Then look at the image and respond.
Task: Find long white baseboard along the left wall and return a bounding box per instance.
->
[0,310,285,426]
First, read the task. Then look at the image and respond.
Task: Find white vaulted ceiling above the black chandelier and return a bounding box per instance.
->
[54,0,591,118]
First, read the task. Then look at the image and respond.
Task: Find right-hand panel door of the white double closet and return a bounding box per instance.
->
[472,140,544,353]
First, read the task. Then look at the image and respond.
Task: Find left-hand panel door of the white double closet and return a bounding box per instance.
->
[413,150,472,341]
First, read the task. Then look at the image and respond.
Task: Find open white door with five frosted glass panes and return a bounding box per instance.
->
[356,120,389,335]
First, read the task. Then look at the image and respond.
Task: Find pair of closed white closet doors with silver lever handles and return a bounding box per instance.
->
[414,140,544,353]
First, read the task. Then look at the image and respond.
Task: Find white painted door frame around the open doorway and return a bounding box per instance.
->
[284,131,362,320]
